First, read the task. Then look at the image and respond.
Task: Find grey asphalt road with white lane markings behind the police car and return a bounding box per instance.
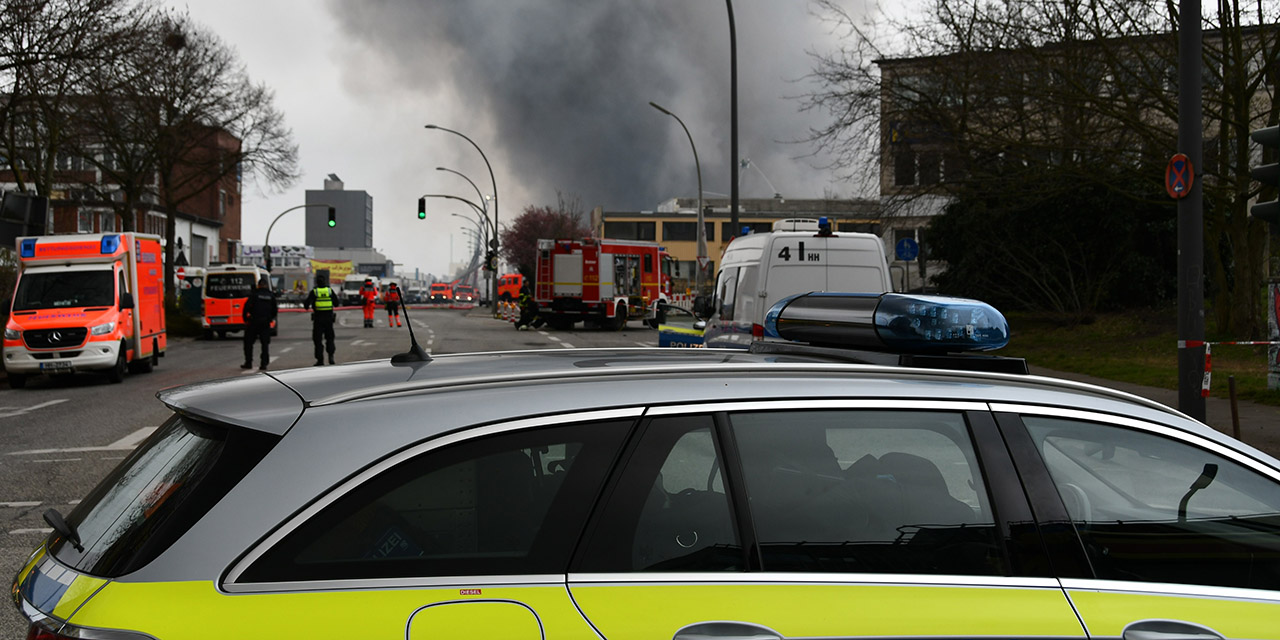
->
[0,308,658,639]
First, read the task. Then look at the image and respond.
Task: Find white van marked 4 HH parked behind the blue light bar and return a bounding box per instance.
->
[703,218,893,348]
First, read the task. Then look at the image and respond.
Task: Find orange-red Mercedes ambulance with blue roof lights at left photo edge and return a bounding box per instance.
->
[4,233,166,389]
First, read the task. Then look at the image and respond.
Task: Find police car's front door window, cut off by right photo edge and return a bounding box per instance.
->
[1023,416,1280,590]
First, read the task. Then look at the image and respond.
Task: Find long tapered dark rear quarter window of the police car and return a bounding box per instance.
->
[238,421,630,582]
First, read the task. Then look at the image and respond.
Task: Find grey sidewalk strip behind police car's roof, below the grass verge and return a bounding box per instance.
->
[1030,366,1280,458]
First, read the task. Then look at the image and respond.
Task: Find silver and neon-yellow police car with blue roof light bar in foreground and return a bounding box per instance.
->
[13,293,1280,640]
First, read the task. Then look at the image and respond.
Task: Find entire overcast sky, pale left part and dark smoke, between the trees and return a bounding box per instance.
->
[172,0,860,274]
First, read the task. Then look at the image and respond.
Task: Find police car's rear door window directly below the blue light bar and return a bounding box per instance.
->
[730,410,1007,575]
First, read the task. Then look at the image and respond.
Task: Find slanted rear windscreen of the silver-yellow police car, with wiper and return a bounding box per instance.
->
[49,415,279,577]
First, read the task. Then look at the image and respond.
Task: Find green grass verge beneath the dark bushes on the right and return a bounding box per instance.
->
[998,307,1280,406]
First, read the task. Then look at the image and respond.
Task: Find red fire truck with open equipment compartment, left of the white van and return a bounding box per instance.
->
[534,238,675,330]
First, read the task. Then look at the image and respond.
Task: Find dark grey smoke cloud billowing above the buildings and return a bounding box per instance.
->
[329,0,860,210]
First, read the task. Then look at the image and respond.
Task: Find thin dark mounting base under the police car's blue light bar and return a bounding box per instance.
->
[750,340,1030,375]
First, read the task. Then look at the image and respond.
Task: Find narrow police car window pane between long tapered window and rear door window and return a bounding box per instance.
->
[577,416,745,572]
